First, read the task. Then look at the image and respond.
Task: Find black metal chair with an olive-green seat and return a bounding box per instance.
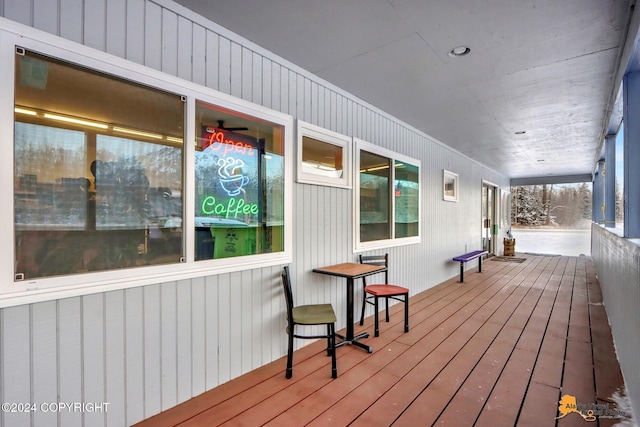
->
[282,266,338,378]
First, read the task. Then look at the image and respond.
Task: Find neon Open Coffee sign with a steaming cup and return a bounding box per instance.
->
[201,126,260,219]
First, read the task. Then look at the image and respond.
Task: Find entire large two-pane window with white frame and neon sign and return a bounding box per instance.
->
[0,28,293,306]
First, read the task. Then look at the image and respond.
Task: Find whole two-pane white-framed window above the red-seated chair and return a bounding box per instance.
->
[354,140,420,250]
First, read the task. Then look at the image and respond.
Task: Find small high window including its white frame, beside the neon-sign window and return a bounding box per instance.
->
[298,121,351,188]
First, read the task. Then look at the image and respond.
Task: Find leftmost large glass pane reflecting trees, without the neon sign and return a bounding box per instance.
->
[14,48,185,281]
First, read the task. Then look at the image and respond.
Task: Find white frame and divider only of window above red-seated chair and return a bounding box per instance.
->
[353,138,422,253]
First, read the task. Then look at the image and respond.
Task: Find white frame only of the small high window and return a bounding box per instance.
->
[296,120,353,189]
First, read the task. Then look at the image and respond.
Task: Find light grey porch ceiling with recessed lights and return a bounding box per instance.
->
[177,0,635,178]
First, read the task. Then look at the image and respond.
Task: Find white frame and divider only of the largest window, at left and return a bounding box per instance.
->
[0,21,294,308]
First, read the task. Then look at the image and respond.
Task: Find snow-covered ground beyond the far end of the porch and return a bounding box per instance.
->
[511,228,591,256]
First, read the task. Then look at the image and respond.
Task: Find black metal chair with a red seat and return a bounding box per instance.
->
[360,254,409,337]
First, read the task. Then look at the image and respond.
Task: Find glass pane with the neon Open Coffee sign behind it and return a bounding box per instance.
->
[195,102,285,260]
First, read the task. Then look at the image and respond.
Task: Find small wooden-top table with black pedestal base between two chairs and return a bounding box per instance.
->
[313,262,387,353]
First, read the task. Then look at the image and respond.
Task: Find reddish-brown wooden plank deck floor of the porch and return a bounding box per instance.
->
[139,254,623,427]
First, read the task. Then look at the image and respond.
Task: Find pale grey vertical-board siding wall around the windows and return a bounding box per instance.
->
[0,0,508,427]
